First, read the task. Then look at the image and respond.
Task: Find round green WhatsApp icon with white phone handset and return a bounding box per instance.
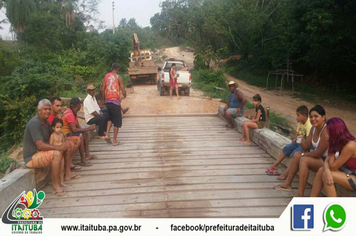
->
[324,203,346,231]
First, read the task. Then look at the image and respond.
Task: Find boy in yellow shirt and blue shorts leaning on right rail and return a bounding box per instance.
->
[266,105,312,177]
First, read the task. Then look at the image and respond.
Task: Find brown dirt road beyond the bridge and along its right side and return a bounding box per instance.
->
[123,47,356,135]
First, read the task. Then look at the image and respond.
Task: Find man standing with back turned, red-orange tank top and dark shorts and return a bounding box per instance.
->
[103,63,126,146]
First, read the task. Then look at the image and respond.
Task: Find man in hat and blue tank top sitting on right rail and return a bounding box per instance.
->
[219,81,247,129]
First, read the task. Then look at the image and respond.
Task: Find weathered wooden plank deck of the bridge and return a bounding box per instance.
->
[41,115,310,218]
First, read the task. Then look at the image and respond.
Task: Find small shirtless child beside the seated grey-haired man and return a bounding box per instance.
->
[49,118,67,187]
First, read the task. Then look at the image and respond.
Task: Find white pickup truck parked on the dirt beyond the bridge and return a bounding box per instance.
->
[157,58,192,96]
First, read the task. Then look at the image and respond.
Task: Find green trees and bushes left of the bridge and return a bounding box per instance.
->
[0,0,176,155]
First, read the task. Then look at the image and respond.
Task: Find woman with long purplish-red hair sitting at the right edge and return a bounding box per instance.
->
[310,117,356,197]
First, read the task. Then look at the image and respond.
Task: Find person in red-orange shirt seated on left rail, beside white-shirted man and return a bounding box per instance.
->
[62,97,97,166]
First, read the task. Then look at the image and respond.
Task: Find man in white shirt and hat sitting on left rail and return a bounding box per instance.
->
[83,84,108,139]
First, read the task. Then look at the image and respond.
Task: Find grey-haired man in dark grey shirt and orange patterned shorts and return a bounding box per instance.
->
[23,99,70,196]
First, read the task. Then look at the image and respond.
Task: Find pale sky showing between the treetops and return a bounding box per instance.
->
[0,0,164,40]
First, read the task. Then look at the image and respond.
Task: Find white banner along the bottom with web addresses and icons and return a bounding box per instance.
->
[0,194,356,236]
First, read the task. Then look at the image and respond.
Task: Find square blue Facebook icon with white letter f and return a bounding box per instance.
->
[292,205,314,230]
